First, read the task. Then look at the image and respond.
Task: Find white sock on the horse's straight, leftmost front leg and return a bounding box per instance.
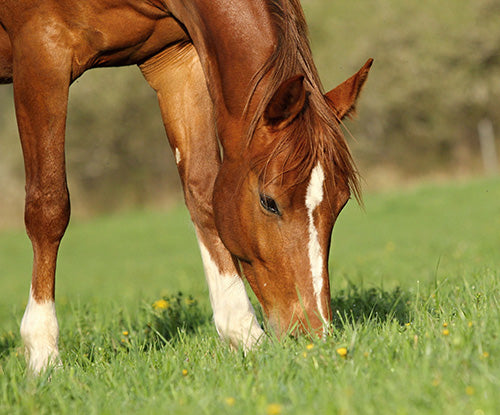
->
[21,289,59,374]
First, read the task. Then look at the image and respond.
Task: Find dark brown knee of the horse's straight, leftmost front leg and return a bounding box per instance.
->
[24,186,70,243]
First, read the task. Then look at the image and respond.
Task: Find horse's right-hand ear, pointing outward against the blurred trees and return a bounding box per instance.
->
[325,58,373,120]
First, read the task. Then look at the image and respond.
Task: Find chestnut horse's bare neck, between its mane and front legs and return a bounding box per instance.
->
[169,0,277,146]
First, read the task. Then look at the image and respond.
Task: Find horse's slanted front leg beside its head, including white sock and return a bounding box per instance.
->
[141,44,263,350]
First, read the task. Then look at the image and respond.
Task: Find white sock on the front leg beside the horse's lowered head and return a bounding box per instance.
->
[198,239,264,350]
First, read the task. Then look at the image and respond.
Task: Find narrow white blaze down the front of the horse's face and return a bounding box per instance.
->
[306,163,326,322]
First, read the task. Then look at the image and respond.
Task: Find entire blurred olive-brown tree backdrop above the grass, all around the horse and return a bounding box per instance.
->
[0,0,500,227]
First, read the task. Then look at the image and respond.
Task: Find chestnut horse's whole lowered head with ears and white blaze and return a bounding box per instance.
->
[213,60,372,336]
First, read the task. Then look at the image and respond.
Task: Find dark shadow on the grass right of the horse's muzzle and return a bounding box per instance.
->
[331,284,410,328]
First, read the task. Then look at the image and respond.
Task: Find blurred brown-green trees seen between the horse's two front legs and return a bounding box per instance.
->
[66,67,180,214]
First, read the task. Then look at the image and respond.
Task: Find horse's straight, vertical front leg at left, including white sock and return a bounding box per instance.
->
[13,28,71,374]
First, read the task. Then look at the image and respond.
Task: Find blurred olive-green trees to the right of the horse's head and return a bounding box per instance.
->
[304,0,500,184]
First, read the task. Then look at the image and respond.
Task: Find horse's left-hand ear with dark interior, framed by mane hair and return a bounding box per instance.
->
[264,75,306,129]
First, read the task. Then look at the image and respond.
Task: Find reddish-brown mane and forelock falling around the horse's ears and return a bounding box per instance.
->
[247,0,361,201]
